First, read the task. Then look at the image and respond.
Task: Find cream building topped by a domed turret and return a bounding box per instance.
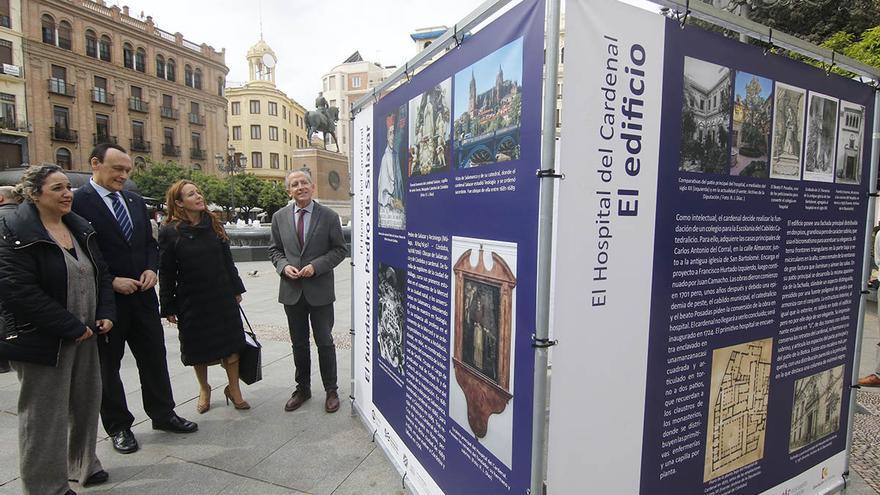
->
[226,39,308,181]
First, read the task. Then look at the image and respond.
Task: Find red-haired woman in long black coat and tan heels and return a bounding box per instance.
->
[159,180,250,414]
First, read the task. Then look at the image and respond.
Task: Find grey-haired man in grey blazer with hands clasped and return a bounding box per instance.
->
[269,171,346,413]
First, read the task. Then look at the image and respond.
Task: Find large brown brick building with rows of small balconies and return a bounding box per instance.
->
[23,0,229,173]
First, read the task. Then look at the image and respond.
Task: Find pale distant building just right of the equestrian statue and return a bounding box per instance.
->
[320,52,393,156]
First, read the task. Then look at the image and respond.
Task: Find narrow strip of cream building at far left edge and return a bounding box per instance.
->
[0,0,30,169]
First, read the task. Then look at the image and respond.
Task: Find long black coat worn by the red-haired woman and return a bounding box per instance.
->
[159,215,245,365]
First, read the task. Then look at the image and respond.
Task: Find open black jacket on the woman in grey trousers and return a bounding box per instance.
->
[0,204,116,366]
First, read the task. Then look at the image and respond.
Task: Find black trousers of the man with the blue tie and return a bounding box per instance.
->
[98,293,174,435]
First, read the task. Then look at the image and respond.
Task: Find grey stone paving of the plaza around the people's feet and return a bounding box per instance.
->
[0,260,880,495]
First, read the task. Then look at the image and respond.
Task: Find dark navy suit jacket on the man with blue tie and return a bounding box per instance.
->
[73,183,159,307]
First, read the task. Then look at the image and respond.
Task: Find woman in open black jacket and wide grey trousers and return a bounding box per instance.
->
[0,165,116,495]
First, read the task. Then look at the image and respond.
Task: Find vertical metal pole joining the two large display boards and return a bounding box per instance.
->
[530,0,560,495]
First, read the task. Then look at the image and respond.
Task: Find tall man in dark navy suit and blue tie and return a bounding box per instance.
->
[73,144,198,454]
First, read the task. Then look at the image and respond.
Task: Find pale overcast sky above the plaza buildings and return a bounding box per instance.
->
[113,0,482,109]
